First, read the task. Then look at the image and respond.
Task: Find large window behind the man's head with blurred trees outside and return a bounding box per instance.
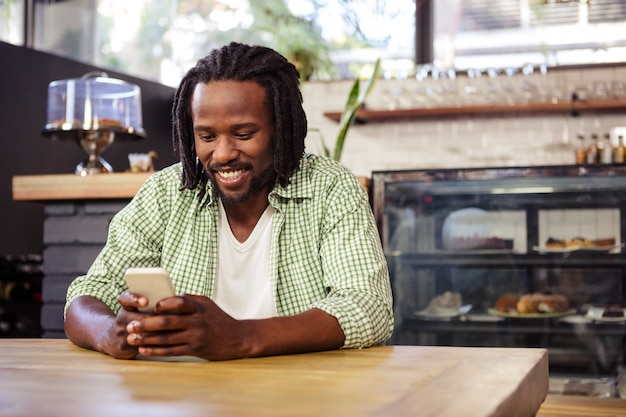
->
[0,0,415,85]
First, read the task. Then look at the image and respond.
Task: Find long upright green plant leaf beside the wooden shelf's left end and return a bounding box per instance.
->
[322,58,381,161]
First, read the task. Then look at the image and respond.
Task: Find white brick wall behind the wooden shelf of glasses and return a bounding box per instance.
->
[302,66,626,176]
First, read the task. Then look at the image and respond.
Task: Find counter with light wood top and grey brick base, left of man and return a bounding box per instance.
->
[11,172,152,336]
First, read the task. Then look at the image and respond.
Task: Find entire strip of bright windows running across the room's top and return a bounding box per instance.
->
[0,0,626,86]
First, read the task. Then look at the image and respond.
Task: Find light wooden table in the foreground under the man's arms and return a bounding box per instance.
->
[0,339,548,417]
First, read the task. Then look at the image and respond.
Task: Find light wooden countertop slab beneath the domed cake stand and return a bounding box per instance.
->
[13,172,152,201]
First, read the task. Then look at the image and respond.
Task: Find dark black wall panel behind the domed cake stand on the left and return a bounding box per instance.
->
[0,42,176,255]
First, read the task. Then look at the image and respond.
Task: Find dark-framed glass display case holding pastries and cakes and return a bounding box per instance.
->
[371,165,626,377]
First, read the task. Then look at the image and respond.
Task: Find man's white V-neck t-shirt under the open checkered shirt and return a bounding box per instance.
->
[213,202,278,320]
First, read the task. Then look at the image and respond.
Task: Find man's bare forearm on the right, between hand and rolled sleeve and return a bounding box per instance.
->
[241,309,345,357]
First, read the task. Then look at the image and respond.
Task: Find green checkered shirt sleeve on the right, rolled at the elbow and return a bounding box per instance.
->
[315,172,394,348]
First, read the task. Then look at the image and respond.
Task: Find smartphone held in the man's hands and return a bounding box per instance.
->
[124,267,176,313]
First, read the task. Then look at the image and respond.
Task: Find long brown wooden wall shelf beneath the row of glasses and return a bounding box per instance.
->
[324,99,626,123]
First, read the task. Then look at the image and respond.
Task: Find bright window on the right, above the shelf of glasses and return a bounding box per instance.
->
[434,0,626,69]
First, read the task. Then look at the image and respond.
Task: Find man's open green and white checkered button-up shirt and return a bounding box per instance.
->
[66,155,393,348]
